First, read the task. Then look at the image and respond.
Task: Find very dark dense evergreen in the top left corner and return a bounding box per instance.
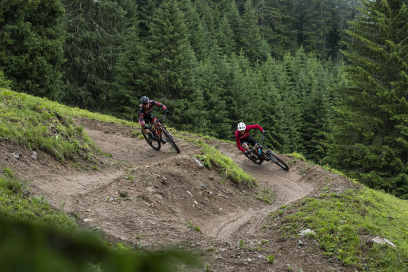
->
[0,0,64,99]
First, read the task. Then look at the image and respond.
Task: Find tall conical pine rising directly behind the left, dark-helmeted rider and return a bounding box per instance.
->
[148,0,207,132]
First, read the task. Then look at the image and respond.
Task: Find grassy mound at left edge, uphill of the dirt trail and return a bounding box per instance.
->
[0,89,98,161]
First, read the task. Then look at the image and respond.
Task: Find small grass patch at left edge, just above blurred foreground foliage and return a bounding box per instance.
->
[0,168,76,231]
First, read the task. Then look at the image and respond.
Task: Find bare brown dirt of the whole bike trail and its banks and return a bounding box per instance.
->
[0,118,356,272]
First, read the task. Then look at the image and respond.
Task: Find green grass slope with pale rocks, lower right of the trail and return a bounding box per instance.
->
[282,188,408,271]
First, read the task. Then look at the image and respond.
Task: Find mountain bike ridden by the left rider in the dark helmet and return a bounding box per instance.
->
[142,115,180,153]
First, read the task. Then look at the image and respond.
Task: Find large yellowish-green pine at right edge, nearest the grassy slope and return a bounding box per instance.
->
[330,0,408,199]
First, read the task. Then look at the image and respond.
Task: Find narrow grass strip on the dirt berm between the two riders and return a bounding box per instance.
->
[176,134,258,186]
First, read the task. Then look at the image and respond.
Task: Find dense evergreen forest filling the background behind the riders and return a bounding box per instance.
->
[0,0,408,199]
